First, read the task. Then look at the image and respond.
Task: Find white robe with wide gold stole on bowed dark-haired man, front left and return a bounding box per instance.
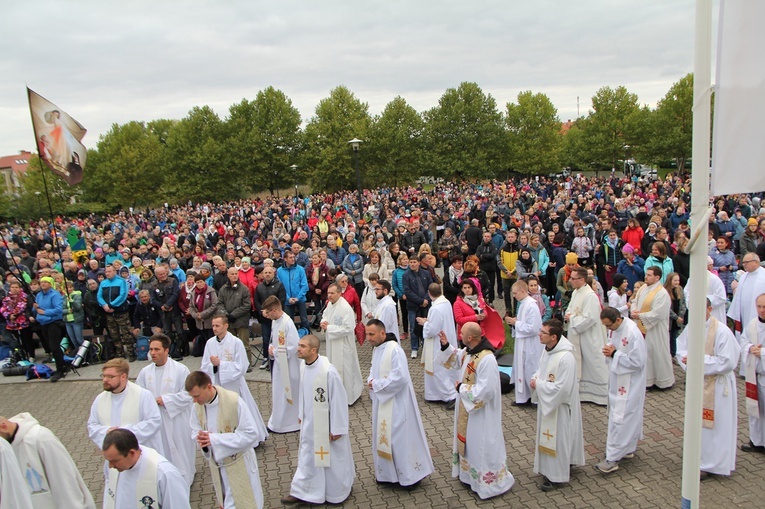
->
[189,386,263,509]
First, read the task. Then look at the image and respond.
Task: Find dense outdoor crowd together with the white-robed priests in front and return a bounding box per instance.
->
[0,175,765,507]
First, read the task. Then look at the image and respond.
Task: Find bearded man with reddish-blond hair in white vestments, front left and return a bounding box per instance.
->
[88,358,164,454]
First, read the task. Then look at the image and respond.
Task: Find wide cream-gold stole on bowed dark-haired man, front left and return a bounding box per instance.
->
[194,385,255,507]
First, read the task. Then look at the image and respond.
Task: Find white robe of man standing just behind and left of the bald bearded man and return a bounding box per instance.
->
[420,295,459,401]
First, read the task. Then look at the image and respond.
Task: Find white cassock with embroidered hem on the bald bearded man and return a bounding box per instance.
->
[437,338,515,499]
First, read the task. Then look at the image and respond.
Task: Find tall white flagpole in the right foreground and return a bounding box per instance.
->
[681,0,712,509]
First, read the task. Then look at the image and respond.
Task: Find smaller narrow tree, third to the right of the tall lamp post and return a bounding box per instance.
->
[505,90,561,175]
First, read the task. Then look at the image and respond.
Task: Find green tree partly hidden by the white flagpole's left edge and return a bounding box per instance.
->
[647,73,693,173]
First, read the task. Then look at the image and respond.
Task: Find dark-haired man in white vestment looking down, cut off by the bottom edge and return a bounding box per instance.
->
[101,428,191,509]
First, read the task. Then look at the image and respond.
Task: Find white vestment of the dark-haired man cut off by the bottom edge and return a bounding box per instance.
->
[104,446,191,509]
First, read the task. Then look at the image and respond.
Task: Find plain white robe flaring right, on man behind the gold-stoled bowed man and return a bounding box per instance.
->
[199,332,268,445]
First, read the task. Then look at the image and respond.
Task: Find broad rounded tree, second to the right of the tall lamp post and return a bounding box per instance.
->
[424,82,507,180]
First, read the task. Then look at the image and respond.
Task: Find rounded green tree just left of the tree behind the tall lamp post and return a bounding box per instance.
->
[226,87,302,194]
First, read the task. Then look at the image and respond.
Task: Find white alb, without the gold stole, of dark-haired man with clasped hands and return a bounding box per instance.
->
[190,390,263,509]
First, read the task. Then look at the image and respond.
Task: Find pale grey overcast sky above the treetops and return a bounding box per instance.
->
[0,0,717,155]
